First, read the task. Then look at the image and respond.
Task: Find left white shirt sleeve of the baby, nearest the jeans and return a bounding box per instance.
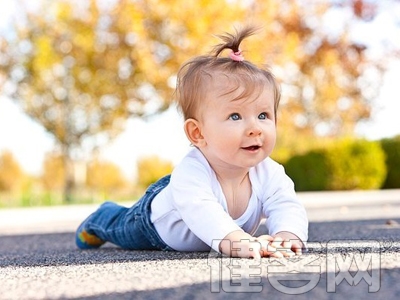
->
[170,151,243,252]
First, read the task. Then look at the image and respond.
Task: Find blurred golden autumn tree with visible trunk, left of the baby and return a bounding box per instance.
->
[0,0,244,200]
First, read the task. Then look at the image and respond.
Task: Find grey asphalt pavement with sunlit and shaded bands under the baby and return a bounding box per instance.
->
[0,190,400,300]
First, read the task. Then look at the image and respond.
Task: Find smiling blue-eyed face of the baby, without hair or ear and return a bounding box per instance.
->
[196,78,276,168]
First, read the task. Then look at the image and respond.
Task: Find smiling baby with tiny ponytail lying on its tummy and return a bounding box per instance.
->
[76,27,308,258]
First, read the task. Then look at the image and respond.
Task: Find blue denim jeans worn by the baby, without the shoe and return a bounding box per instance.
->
[81,175,173,251]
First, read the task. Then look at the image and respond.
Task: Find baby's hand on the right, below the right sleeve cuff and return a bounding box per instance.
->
[256,235,295,258]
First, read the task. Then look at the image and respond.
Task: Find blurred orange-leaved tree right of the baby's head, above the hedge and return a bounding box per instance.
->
[244,0,396,155]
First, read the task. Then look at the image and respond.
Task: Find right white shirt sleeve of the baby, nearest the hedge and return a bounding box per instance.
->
[257,159,308,242]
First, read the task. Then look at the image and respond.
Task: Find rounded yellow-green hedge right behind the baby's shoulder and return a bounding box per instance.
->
[284,140,386,191]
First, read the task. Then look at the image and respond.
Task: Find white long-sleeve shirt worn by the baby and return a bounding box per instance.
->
[151,148,308,251]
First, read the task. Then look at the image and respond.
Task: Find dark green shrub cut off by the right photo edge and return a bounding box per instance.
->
[381,136,400,189]
